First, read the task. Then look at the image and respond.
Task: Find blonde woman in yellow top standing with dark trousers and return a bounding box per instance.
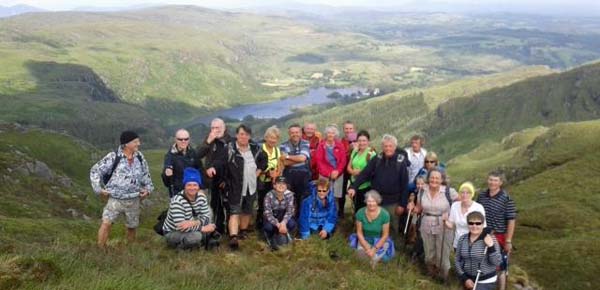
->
[256,126,283,230]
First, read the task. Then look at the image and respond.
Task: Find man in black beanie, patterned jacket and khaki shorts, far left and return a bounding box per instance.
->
[90,131,154,247]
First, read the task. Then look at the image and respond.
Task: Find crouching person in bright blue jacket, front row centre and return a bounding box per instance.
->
[298,178,338,240]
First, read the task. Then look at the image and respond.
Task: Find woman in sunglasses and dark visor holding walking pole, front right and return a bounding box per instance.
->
[455,211,502,290]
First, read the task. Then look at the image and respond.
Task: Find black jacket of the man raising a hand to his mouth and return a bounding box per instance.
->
[197,132,233,184]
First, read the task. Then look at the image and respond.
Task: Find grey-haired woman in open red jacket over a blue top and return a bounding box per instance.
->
[315,125,348,212]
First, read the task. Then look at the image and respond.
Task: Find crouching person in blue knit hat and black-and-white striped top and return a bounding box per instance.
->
[163,167,215,249]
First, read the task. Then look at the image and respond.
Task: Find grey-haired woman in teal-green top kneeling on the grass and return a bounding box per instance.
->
[350,190,394,268]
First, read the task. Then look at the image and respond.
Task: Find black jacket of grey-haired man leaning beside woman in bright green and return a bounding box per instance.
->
[350,150,408,207]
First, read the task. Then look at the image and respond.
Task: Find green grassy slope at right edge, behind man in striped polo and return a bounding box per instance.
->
[448,120,600,289]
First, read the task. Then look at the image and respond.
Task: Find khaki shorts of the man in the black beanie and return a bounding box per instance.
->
[102,197,140,229]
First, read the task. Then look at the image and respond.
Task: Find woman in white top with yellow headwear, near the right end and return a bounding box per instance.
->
[442,182,486,249]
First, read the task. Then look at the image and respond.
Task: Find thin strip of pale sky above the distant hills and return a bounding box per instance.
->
[0,0,600,15]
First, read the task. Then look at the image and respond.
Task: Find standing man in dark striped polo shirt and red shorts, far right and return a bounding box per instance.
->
[477,171,517,290]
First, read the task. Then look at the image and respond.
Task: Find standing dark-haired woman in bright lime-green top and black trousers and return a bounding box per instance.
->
[346,130,377,214]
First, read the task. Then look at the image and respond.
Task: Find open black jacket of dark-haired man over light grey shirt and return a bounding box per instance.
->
[225,140,267,197]
